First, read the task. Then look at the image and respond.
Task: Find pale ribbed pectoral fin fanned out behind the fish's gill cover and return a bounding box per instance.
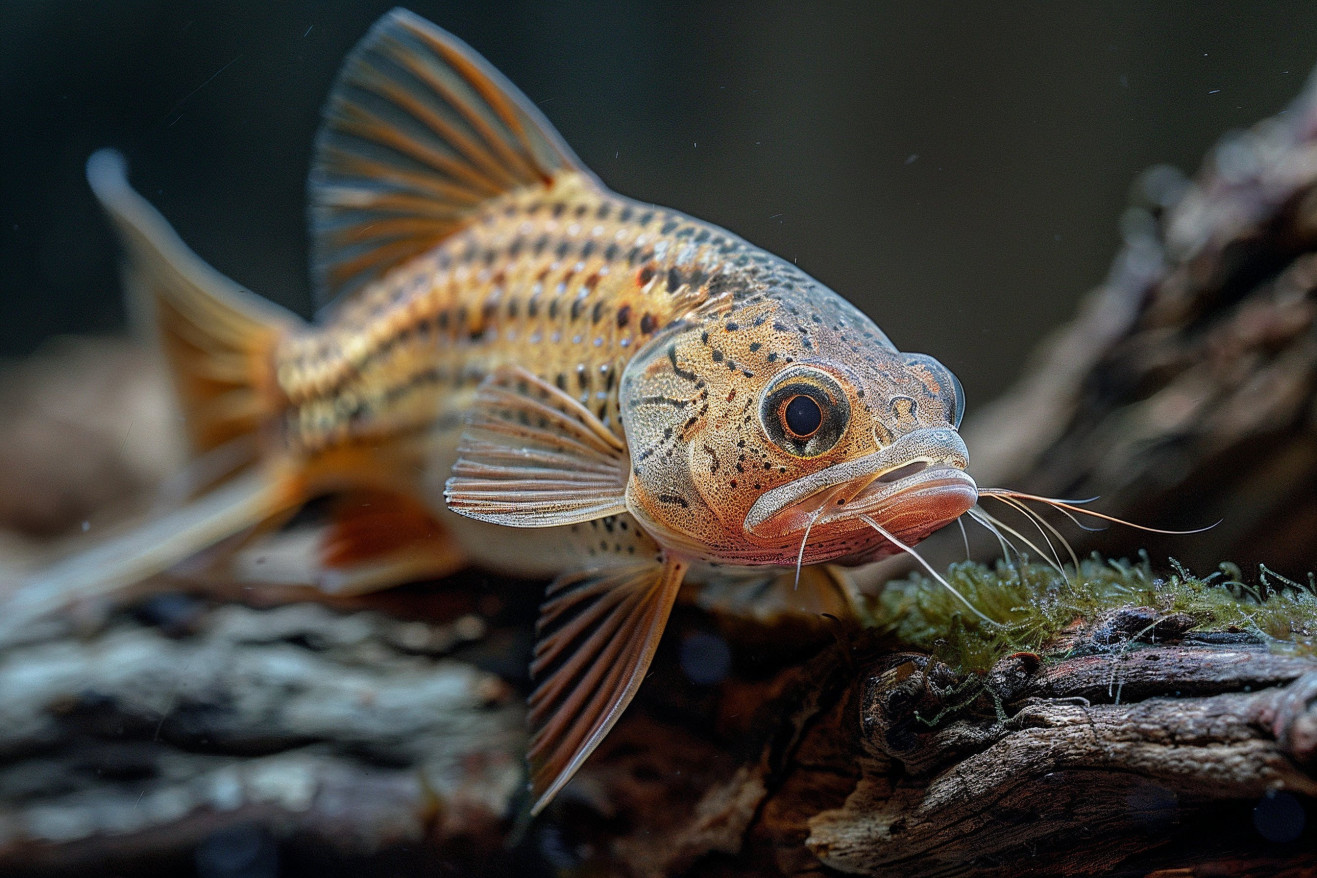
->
[444,369,631,528]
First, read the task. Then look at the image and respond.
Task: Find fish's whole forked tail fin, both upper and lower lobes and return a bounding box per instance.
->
[0,150,313,640]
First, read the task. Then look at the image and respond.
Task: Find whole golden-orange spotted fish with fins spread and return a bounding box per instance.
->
[11,11,979,811]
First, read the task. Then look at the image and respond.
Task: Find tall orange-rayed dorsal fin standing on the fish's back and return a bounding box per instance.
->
[309,9,594,304]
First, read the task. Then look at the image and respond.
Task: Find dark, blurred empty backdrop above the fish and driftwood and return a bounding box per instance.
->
[0,0,1317,405]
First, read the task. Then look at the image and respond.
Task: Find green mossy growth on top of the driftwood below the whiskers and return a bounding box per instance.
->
[871,555,1317,671]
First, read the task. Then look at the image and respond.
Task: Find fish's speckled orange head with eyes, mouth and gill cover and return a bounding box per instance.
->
[619,290,979,566]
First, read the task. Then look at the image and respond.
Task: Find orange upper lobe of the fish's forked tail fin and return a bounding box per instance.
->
[87,150,300,453]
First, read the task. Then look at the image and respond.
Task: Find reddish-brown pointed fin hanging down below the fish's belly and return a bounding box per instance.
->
[531,559,685,815]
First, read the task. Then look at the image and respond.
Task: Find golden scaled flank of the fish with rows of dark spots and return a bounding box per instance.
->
[275,178,821,450]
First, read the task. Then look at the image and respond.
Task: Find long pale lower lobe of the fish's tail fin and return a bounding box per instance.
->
[0,470,304,642]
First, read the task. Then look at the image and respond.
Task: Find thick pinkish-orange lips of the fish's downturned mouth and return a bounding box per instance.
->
[745,428,979,541]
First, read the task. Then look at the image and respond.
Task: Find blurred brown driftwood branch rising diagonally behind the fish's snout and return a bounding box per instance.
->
[965,68,1317,575]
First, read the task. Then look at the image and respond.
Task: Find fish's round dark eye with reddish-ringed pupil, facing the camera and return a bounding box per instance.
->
[759,366,851,457]
